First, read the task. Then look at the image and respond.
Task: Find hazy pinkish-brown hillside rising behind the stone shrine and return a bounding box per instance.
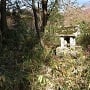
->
[64,4,90,26]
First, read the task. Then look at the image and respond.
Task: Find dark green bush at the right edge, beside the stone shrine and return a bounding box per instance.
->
[77,21,90,49]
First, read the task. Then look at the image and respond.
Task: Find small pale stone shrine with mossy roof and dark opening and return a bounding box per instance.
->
[56,27,80,55]
